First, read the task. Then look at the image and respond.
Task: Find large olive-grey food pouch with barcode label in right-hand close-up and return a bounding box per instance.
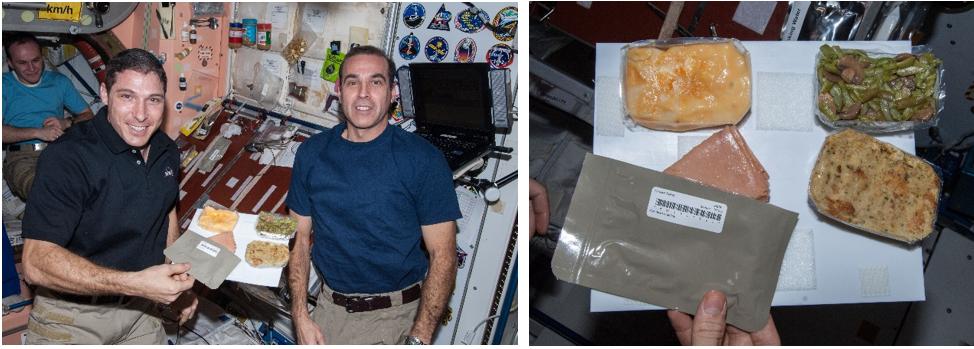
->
[551,154,798,332]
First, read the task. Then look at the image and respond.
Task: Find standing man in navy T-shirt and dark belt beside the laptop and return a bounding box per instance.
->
[287,46,461,344]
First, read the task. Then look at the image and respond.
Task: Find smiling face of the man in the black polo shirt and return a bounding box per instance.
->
[101,70,166,157]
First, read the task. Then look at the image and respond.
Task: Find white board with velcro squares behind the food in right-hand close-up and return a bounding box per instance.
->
[590,41,925,312]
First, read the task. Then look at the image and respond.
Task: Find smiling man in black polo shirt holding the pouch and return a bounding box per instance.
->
[23,49,196,344]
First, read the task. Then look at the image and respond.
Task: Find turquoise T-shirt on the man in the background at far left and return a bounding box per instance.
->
[3,70,88,144]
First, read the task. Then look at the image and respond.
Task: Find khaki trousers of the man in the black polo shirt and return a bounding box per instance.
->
[26,288,166,345]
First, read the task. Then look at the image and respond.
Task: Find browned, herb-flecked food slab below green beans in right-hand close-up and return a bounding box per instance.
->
[808,130,940,242]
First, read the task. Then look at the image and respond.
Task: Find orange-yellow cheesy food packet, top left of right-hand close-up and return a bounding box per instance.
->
[624,42,751,131]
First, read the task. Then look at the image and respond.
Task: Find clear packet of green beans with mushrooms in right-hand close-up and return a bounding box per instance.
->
[814,44,945,133]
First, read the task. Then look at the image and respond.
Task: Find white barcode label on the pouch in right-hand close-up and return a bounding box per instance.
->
[646,187,727,234]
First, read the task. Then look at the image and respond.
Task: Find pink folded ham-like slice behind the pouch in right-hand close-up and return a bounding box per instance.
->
[663,125,771,202]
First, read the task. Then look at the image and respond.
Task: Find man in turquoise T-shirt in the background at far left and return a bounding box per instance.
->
[3,32,93,200]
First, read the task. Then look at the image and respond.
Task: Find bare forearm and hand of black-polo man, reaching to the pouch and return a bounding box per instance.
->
[23,239,196,304]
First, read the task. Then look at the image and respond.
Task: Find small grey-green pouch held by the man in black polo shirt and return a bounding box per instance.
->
[162,230,240,290]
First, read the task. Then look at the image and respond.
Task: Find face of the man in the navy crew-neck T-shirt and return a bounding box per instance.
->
[337,54,394,141]
